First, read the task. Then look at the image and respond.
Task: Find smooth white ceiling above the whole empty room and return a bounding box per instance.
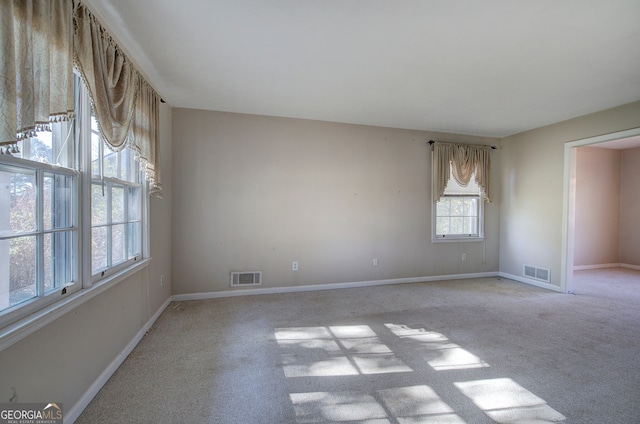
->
[85,0,640,137]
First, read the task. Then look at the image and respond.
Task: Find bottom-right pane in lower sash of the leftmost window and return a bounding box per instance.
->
[44,231,73,292]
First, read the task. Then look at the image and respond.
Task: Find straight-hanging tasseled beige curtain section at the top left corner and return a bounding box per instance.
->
[0,0,73,153]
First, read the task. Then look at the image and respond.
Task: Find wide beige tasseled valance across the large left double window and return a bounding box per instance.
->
[0,0,162,197]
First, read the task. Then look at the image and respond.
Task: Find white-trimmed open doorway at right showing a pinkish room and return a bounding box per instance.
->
[561,128,640,293]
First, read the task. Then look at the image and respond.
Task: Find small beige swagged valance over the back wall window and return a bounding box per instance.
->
[433,142,491,203]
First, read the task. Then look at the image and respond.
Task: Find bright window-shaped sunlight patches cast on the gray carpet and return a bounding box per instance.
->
[275,323,566,424]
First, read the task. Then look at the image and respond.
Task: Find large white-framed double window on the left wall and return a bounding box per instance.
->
[0,77,146,328]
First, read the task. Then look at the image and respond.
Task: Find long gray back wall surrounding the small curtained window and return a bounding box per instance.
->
[173,109,500,294]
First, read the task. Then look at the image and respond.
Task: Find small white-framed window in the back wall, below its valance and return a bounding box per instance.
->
[432,169,484,241]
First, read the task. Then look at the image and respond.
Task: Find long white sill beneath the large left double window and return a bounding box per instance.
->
[0,258,151,352]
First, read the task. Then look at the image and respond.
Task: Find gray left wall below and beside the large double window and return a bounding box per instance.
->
[0,105,172,411]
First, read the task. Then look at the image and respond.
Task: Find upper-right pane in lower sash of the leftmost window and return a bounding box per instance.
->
[43,173,73,230]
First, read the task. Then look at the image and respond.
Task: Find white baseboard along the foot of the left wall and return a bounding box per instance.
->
[64,298,171,424]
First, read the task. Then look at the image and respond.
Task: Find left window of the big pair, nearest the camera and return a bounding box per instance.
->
[0,122,79,322]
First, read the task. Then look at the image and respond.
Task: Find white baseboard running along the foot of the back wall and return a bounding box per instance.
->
[171,272,498,301]
